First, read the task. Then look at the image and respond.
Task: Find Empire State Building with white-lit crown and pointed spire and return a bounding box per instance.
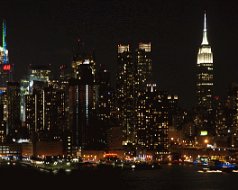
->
[197,13,213,110]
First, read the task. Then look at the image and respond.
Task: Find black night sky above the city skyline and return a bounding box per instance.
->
[0,0,238,108]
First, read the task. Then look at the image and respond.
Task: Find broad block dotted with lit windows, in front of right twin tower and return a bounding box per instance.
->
[136,83,170,159]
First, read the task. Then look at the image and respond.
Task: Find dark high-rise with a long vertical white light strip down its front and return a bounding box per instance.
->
[69,79,96,148]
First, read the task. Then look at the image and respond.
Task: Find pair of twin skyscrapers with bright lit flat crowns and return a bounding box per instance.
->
[117,43,152,150]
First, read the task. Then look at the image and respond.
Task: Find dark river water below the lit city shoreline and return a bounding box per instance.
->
[0,165,238,190]
